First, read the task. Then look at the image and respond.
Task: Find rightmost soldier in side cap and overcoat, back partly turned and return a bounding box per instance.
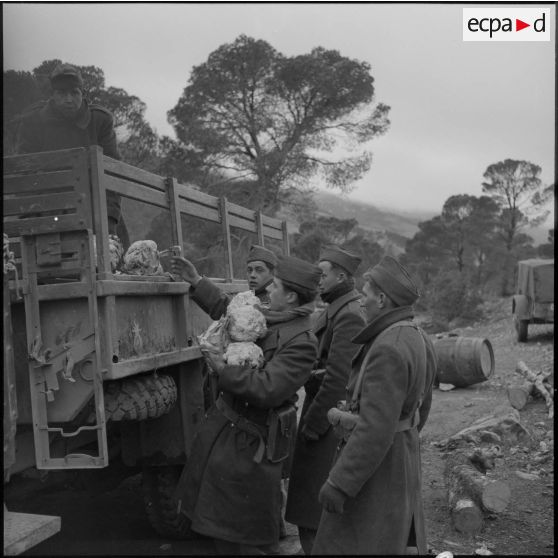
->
[312,256,436,556]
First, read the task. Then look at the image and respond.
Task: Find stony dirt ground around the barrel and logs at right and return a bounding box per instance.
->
[421,298,554,555]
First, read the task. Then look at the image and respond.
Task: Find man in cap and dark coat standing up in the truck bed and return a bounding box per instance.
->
[15,64,129,246]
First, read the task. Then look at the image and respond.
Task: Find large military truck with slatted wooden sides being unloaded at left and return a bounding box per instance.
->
[3,146,289,538]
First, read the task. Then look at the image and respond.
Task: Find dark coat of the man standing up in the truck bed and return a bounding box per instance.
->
[16,99,120,221]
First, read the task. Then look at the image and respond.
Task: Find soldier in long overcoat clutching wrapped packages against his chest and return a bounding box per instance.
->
[172,257,321,554]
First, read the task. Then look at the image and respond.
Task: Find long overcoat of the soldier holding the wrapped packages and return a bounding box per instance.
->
[176,280,317,545]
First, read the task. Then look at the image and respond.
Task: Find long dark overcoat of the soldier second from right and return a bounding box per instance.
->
[285,290,364,529]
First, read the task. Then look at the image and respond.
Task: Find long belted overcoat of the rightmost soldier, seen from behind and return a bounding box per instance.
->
[312,307,436,555]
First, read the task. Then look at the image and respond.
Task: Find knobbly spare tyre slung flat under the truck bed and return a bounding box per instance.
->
[104,374,177,421]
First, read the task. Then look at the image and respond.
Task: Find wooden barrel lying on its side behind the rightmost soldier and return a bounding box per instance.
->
[432,337,494,387]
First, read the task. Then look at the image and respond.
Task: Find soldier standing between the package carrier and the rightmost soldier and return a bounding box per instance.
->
[285,246,364,554]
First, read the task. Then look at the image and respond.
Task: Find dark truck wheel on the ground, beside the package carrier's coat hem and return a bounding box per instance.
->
[142,465,201,539]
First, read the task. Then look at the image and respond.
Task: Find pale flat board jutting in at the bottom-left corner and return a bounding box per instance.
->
[4,509,60,556]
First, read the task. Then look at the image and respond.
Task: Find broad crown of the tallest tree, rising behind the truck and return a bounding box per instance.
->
[168,35,389,213]
